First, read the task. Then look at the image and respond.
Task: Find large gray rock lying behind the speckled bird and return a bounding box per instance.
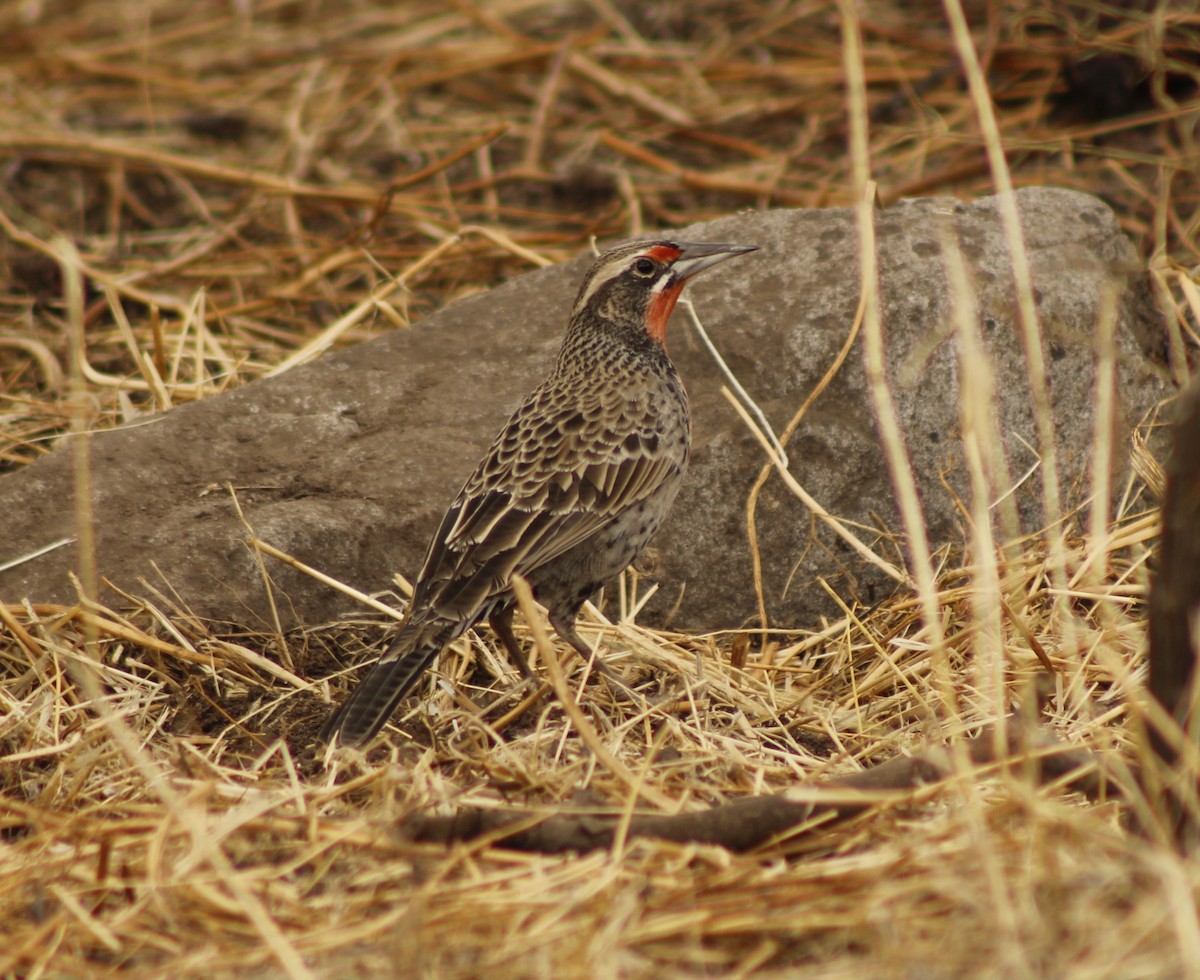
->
[0,188,1170,627]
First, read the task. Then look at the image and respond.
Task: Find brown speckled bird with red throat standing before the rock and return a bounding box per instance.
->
[317,240,757,746]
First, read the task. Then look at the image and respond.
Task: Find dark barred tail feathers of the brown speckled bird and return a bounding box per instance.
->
[317,631,445,745]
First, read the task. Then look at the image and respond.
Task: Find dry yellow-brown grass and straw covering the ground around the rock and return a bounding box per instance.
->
[0,0,1200,976]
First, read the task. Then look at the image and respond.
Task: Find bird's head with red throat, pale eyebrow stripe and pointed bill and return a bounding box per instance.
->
[571,241,758,347]
